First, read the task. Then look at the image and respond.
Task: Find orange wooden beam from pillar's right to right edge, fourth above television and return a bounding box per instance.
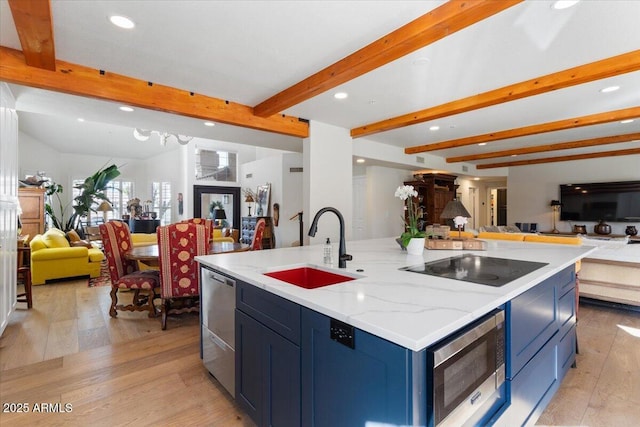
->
[351,50,640,138]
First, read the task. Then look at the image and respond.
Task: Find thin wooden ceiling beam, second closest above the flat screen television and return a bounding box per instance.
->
[447,132,640,163]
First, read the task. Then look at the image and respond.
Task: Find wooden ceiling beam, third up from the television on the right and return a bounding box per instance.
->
[404,107,640,154]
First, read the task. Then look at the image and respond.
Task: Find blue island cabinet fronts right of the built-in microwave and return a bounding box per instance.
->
[497,266,576,426]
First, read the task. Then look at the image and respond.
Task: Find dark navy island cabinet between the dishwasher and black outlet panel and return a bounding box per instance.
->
[236,282,301,427]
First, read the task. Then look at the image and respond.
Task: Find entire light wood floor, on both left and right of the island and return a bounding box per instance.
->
[0,280,640,427]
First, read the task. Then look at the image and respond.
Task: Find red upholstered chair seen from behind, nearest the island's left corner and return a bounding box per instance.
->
[156,222,209,330]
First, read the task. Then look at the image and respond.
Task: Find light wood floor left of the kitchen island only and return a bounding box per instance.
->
[0,280,254,427]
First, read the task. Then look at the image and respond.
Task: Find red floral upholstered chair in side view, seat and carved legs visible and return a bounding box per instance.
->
[100,221,160,317]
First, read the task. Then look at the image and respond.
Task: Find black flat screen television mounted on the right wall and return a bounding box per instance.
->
[560,181,640,222]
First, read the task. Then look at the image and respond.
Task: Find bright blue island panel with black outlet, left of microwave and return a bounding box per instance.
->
[301,308,427,427]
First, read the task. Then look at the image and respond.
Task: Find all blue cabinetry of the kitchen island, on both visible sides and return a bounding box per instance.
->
[236,266,576,427]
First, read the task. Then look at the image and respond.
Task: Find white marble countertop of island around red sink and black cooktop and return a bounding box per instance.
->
[197,238,595,351]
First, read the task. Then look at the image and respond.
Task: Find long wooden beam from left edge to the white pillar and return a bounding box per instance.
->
[0,46,309,138]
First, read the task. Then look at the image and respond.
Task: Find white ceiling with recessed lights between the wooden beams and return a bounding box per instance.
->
[0,0,640,172]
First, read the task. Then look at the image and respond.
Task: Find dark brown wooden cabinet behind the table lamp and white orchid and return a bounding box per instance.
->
[404,174,458,230]
